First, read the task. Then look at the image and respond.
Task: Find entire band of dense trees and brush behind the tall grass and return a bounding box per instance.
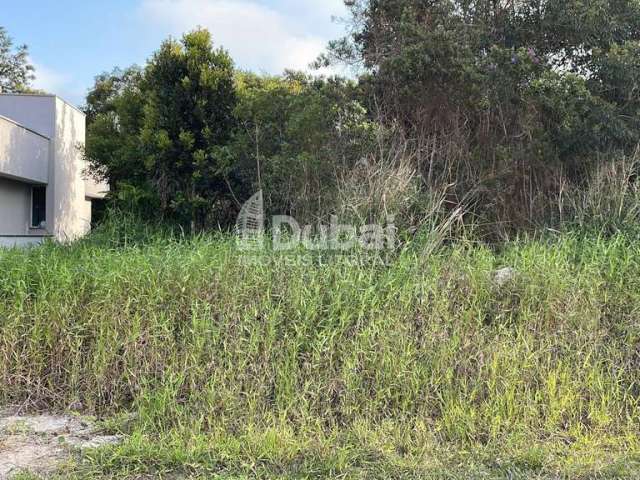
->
[87,0,640,229]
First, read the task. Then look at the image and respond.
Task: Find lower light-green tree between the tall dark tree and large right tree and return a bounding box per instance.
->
[229,72,372,221]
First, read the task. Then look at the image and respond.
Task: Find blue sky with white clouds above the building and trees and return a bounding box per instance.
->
[0,0,346,104]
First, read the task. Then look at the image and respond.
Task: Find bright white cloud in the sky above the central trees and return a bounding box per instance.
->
[141,0,342,73]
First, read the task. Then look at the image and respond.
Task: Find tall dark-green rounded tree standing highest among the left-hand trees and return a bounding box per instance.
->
[140,30,236,231]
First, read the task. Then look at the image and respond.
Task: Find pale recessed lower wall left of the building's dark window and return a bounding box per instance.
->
[0,178,31,236]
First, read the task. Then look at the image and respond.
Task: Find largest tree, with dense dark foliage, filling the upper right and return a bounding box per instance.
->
[320,0,640,232]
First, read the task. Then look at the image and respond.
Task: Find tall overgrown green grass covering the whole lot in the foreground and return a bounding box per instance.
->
[0,234,640,479]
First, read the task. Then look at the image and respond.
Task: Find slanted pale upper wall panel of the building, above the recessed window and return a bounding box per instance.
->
[0,117,49,184]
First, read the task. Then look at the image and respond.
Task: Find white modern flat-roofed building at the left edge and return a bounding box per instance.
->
[0,94,109,246]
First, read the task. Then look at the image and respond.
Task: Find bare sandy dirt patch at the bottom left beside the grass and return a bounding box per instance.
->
[0,408,121,480]
